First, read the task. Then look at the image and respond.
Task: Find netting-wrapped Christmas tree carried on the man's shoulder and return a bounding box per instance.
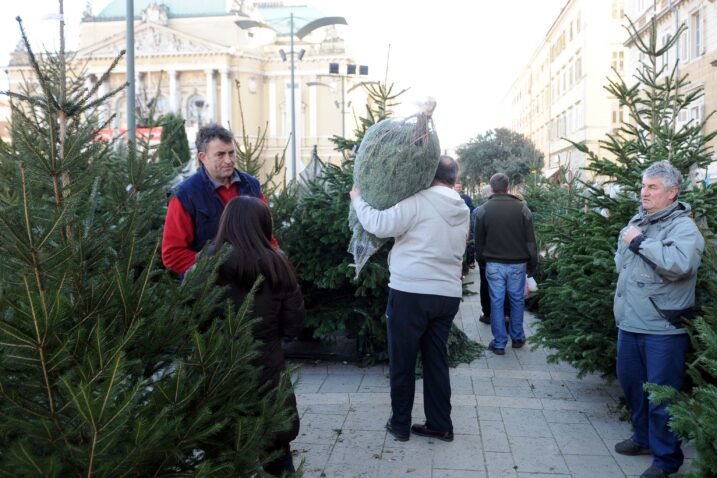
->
[348,103,441,277]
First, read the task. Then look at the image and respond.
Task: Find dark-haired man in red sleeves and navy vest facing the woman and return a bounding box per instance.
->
[162,124,278,275]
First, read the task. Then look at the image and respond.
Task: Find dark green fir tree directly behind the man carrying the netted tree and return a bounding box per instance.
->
[271,83,482,365]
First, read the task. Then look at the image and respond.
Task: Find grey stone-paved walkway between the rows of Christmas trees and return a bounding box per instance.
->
[292,273,694,478]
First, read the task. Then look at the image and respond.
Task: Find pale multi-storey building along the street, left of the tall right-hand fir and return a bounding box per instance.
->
[501,0,626,176]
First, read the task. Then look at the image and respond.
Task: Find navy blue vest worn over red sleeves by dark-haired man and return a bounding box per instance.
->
[172,165,261,252]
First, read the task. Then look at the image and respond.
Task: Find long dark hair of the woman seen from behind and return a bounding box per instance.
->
[213,196,297,292]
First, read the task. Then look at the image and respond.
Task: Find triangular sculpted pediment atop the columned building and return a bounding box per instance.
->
[78,23,228,58]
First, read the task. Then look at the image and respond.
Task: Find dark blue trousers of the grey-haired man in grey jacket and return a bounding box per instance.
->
[617,330,689,473]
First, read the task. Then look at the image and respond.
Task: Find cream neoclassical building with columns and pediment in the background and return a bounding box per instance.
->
[8,0,368,177]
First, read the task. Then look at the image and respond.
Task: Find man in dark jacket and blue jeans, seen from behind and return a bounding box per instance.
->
[475,173,538,355]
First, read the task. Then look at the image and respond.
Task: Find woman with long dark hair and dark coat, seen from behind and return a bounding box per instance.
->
[212,196,305,476]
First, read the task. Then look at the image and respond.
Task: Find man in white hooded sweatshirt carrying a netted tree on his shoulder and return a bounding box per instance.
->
[351,156,469,441]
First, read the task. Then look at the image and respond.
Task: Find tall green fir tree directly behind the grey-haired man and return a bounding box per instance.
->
[533,19,717,376]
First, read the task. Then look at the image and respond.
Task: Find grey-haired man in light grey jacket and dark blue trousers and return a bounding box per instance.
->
[614,161,704,478]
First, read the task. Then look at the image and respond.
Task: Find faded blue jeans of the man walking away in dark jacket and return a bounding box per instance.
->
[485,262,527,349]
